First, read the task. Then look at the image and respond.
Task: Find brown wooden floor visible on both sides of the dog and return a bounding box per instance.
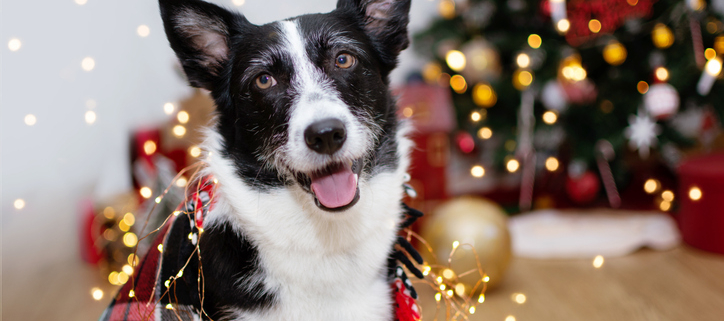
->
[2,247,724,321]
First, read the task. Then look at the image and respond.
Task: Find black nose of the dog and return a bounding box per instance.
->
[304,118,347,155]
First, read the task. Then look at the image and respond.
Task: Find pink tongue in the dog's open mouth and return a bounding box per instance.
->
[312,166,357,208]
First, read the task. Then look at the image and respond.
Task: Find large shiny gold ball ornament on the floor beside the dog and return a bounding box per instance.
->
[421,197,511,295]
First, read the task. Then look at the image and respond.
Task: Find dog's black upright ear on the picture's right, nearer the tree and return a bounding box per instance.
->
[337,0,411,61]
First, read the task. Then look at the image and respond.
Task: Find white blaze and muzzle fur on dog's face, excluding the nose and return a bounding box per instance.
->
[279,21,372,172]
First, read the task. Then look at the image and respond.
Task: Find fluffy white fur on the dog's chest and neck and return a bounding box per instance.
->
[205,129,409,321]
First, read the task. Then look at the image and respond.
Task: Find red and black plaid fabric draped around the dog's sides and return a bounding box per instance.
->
[99,177,420,321]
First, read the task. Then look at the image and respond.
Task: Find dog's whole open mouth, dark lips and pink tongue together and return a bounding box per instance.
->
[296,160,362,212]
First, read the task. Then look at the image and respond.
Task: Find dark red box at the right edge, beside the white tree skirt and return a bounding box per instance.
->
[679,154,724,254]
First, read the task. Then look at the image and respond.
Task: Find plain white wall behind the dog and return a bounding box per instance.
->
[0,0,437,270]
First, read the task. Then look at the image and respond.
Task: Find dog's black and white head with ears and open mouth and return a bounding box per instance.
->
[160,0,410,211]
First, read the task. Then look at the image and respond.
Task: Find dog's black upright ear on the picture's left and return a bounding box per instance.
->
[159,0,240,90]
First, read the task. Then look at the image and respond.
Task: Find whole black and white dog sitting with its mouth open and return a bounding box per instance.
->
[160,0,412,321]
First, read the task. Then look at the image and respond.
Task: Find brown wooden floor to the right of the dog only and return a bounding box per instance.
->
[420,246,724,321]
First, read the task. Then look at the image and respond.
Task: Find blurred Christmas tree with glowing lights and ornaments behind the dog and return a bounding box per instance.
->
[414,0,724,206]
